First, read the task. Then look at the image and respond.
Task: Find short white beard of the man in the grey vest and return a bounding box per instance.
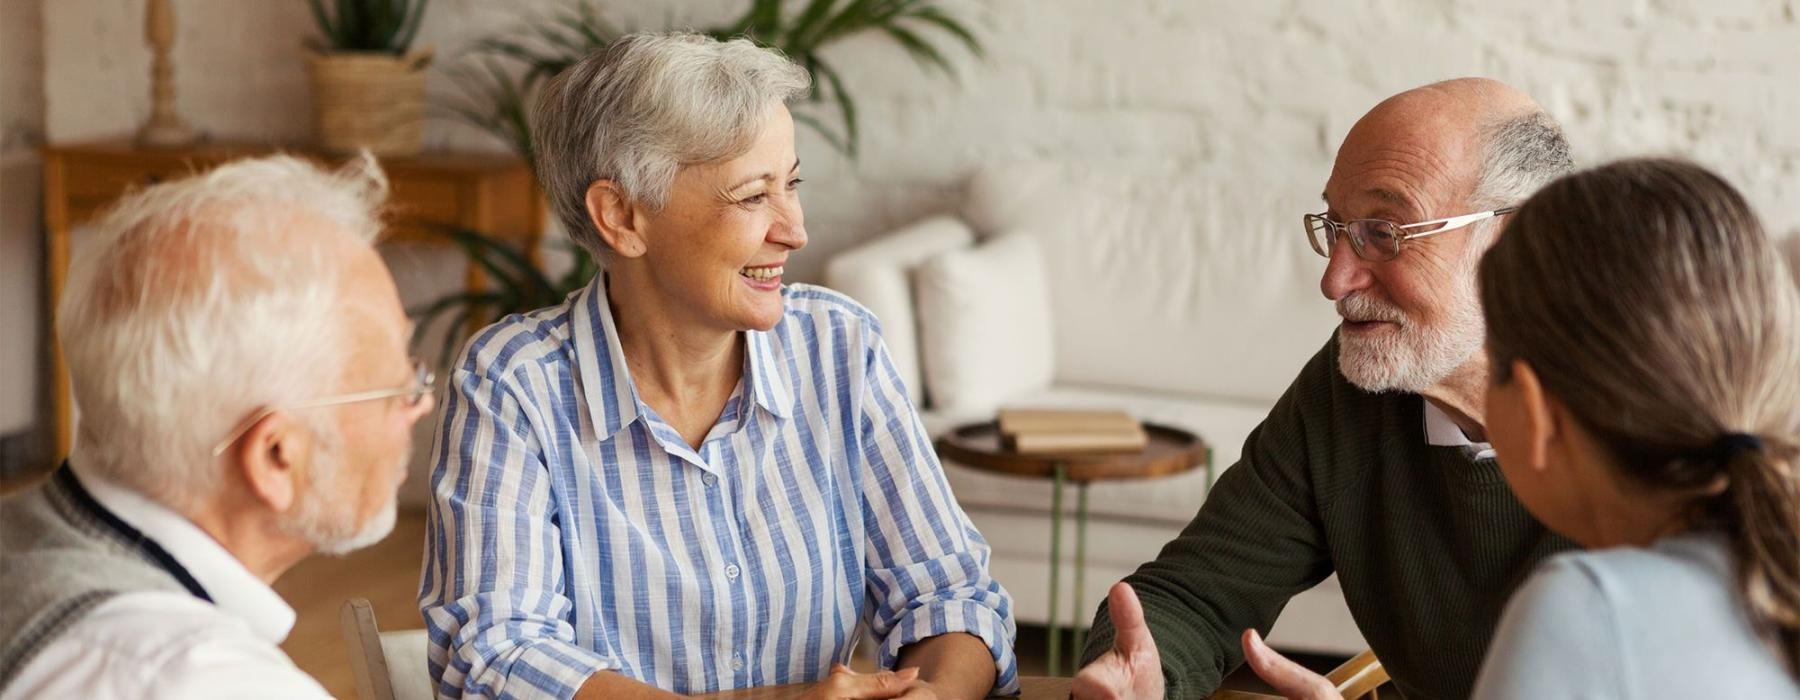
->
[283,441,412,556]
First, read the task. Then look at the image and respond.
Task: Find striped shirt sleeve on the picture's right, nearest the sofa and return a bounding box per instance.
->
[859,335,1019,695]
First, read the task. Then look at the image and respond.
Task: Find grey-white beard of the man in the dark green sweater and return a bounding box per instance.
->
[1337,290,1487,394]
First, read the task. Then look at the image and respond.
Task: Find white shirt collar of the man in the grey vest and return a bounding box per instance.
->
[68,464,293,644]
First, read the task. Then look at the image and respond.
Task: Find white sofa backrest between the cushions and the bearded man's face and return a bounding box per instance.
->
[972,162,1337,403]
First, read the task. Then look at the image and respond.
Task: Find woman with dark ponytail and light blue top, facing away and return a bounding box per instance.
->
[1474,160,1800,698]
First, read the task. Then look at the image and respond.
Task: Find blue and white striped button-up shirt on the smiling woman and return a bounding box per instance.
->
[419,279,1019,698]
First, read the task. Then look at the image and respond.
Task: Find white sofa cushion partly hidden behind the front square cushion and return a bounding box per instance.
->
[824,216,976,405]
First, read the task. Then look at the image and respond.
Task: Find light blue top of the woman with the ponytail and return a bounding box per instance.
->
[1474,534,1800,700]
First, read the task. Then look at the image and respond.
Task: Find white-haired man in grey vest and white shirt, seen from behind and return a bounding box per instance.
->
[0,157,432,698]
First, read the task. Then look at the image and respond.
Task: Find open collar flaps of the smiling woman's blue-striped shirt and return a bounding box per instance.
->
[574,274,794,439]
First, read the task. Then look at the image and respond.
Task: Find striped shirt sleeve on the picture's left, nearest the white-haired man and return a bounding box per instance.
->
[419,369,619,698]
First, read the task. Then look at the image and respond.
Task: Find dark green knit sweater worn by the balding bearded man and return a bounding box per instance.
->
[1082,337,1573,700]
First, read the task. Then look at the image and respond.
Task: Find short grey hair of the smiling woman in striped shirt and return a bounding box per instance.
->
[533,32,812,257]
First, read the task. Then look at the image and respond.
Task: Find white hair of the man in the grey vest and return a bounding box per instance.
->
[56,155,387,509]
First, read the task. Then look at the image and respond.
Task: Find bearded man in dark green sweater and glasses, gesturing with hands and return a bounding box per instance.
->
[1073,79,1573,698]
